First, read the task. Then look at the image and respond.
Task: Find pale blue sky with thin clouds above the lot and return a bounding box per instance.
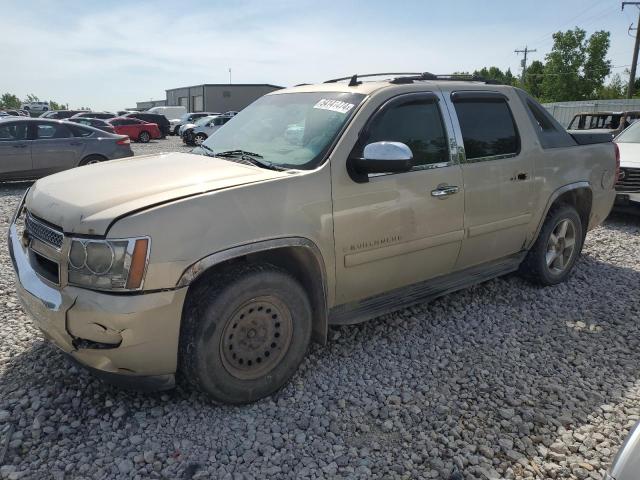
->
[0,0,638,110]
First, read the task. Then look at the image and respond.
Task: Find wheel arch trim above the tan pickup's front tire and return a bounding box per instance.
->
[177,237,328,344]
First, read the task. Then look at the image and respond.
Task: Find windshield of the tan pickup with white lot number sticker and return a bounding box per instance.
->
[194,92,365,170]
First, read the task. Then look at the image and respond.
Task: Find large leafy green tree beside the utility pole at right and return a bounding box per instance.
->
[542,27,611,102]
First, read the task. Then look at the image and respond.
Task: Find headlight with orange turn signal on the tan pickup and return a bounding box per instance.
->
[67,237,151,290]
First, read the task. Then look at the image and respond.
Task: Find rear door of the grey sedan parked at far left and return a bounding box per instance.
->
[31,122,84,176]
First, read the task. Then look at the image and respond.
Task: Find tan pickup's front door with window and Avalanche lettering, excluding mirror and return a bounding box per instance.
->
[332,92,464,305]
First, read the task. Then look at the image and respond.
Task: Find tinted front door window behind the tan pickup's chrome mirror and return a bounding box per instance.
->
[366,99,449,166]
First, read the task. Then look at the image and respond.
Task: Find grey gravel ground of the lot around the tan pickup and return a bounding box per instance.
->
[0,142,640,480]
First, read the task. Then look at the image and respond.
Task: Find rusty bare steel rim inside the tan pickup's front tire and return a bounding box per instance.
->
[220,295,293,380]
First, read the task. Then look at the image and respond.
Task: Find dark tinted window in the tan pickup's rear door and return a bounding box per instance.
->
[454,99,520,160]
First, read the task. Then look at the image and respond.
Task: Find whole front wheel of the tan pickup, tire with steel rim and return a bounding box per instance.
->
[179,264,312,404]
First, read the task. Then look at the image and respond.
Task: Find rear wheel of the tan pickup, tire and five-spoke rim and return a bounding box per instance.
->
[520,205,585,286]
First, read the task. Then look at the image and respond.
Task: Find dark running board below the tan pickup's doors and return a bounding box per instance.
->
[329,252,526,325]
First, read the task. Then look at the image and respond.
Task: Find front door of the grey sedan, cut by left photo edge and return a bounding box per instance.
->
[0,121,33,179]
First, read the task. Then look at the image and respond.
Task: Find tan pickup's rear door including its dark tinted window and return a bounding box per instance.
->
[448,91,535,270]
